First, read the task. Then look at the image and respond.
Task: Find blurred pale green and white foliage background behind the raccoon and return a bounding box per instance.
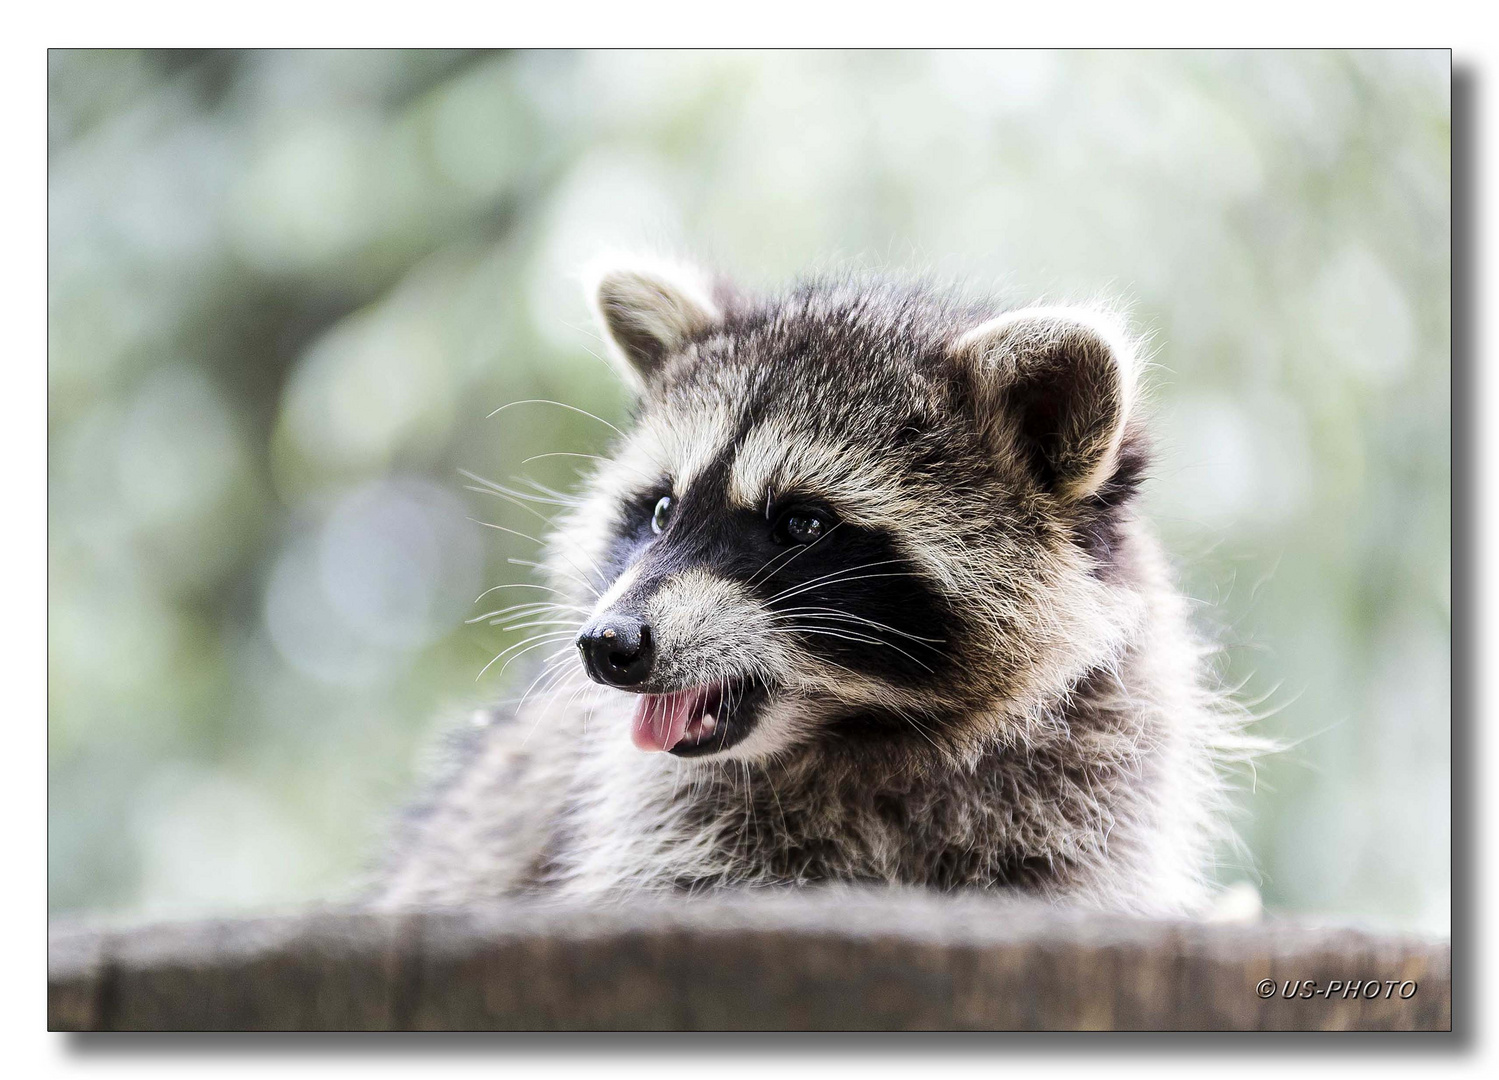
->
[48,51,1451,932]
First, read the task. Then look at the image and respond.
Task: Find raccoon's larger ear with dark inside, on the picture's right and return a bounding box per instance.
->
[952,308,1138,500]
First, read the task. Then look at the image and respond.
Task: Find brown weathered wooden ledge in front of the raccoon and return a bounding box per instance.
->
[48,890,1451,1031]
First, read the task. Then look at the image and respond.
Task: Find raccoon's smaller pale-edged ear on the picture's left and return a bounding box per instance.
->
[588,258,724,389]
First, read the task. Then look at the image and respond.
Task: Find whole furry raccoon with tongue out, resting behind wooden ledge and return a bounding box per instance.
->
[379,260,1247,915]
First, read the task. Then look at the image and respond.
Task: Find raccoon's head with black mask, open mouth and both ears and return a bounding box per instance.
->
[553,264,1142,759]
